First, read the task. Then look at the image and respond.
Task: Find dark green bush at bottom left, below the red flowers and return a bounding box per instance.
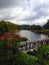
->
[0,41,38,65]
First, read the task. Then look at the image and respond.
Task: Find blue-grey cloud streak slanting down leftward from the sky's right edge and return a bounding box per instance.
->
[16,4,49,21]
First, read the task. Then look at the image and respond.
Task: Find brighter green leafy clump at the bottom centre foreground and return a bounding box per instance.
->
[16,53,38,65]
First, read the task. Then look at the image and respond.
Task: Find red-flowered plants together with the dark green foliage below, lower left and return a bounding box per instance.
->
[0,33,38,65]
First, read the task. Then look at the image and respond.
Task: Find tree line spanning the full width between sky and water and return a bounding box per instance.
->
[0,20,49,35]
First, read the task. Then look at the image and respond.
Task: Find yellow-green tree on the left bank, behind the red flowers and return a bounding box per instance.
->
[0,20,17,36]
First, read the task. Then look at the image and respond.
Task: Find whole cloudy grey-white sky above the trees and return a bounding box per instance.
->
[0,0,49,25]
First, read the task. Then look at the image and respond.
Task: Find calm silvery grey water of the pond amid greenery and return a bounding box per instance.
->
[19,30,47,41]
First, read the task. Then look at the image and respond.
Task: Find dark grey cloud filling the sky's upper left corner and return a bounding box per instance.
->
[0,0,18,9]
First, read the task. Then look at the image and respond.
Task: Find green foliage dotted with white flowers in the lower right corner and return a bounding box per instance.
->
[27,44,49,65]
